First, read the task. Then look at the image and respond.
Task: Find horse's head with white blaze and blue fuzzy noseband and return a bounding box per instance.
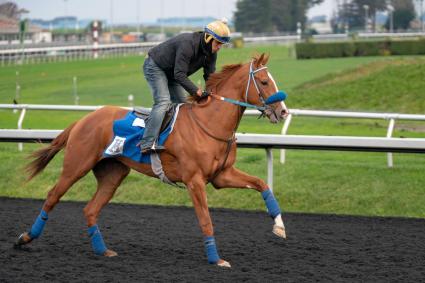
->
[244,53,288,123]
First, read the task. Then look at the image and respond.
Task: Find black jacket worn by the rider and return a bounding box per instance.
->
[148,32,217,95]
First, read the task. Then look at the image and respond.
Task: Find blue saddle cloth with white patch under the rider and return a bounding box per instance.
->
[103,109,178,164]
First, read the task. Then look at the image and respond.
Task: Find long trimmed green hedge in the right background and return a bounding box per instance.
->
[295,39,425,59]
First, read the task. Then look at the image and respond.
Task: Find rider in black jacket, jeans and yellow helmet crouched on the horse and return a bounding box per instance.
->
[140,20,230,154]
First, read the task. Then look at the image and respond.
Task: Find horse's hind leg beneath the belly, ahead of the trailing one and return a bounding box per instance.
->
[84,159,130,257]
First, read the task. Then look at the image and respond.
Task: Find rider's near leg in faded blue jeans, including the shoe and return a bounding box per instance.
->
[140,58,171,152]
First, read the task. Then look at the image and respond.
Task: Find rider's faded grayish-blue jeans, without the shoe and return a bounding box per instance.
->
[140,58,186,149]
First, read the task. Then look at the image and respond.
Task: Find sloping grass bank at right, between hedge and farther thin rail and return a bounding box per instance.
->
[291,57,425,113]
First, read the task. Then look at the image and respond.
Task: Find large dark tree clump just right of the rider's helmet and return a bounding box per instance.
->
[234,0,323,32]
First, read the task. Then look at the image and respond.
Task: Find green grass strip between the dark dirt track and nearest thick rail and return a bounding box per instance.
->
[0,143,425,217]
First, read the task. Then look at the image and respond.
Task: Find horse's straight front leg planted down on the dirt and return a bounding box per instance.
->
[185,175,230,267]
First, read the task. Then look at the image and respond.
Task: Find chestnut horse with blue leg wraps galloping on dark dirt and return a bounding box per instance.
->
[16,54,287,267]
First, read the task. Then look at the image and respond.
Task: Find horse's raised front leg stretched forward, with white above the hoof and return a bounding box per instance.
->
[212,167,286,239]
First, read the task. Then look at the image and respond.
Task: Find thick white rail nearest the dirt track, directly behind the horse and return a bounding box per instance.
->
[0,129,425,192]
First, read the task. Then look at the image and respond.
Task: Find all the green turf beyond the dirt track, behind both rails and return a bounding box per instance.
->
[0,46,425,217]
